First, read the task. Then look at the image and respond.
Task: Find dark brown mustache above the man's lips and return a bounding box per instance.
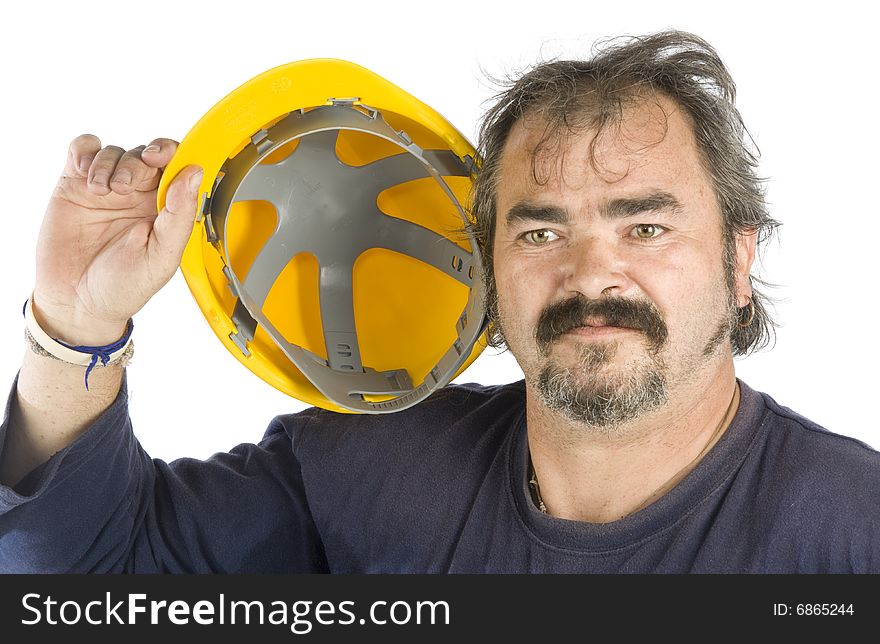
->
[535,294,669,351]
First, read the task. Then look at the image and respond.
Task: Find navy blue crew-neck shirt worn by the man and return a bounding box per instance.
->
[0,381,880,573]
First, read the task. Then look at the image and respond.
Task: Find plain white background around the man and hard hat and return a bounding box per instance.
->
[0,0,880,459]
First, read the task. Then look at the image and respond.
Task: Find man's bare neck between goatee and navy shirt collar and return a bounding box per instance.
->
[526,361,739,523]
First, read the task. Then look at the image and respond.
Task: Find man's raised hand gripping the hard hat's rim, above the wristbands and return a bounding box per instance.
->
[33,134,202,345]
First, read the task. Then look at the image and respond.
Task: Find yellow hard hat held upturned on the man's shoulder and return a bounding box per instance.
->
[158,59,486,413]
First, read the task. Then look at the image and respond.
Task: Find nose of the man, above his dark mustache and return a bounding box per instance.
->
[560,235,631,299]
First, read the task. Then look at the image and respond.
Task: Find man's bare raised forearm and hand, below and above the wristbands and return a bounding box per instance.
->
[0,134,202,486]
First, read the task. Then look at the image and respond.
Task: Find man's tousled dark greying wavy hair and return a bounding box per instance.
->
[468,30,779,355]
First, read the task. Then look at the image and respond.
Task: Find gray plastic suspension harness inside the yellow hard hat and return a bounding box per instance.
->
[199,99,486,413]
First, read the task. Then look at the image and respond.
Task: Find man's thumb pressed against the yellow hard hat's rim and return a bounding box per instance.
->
[149,165,204,277]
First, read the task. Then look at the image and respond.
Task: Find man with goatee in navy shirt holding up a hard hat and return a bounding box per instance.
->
[0,32,880,572]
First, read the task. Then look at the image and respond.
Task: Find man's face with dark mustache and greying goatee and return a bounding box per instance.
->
[494,97,754,427]
